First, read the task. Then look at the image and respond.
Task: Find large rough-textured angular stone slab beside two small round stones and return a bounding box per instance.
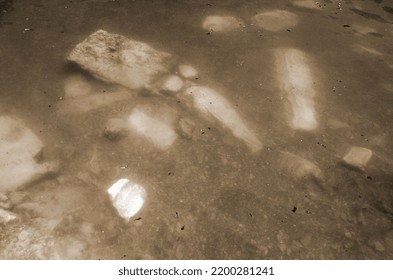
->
[68,30,173,89]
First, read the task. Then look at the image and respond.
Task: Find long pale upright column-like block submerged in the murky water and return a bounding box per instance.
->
[275,49,318,130]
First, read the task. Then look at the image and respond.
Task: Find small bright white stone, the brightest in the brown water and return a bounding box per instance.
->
[108,179,146,221]
